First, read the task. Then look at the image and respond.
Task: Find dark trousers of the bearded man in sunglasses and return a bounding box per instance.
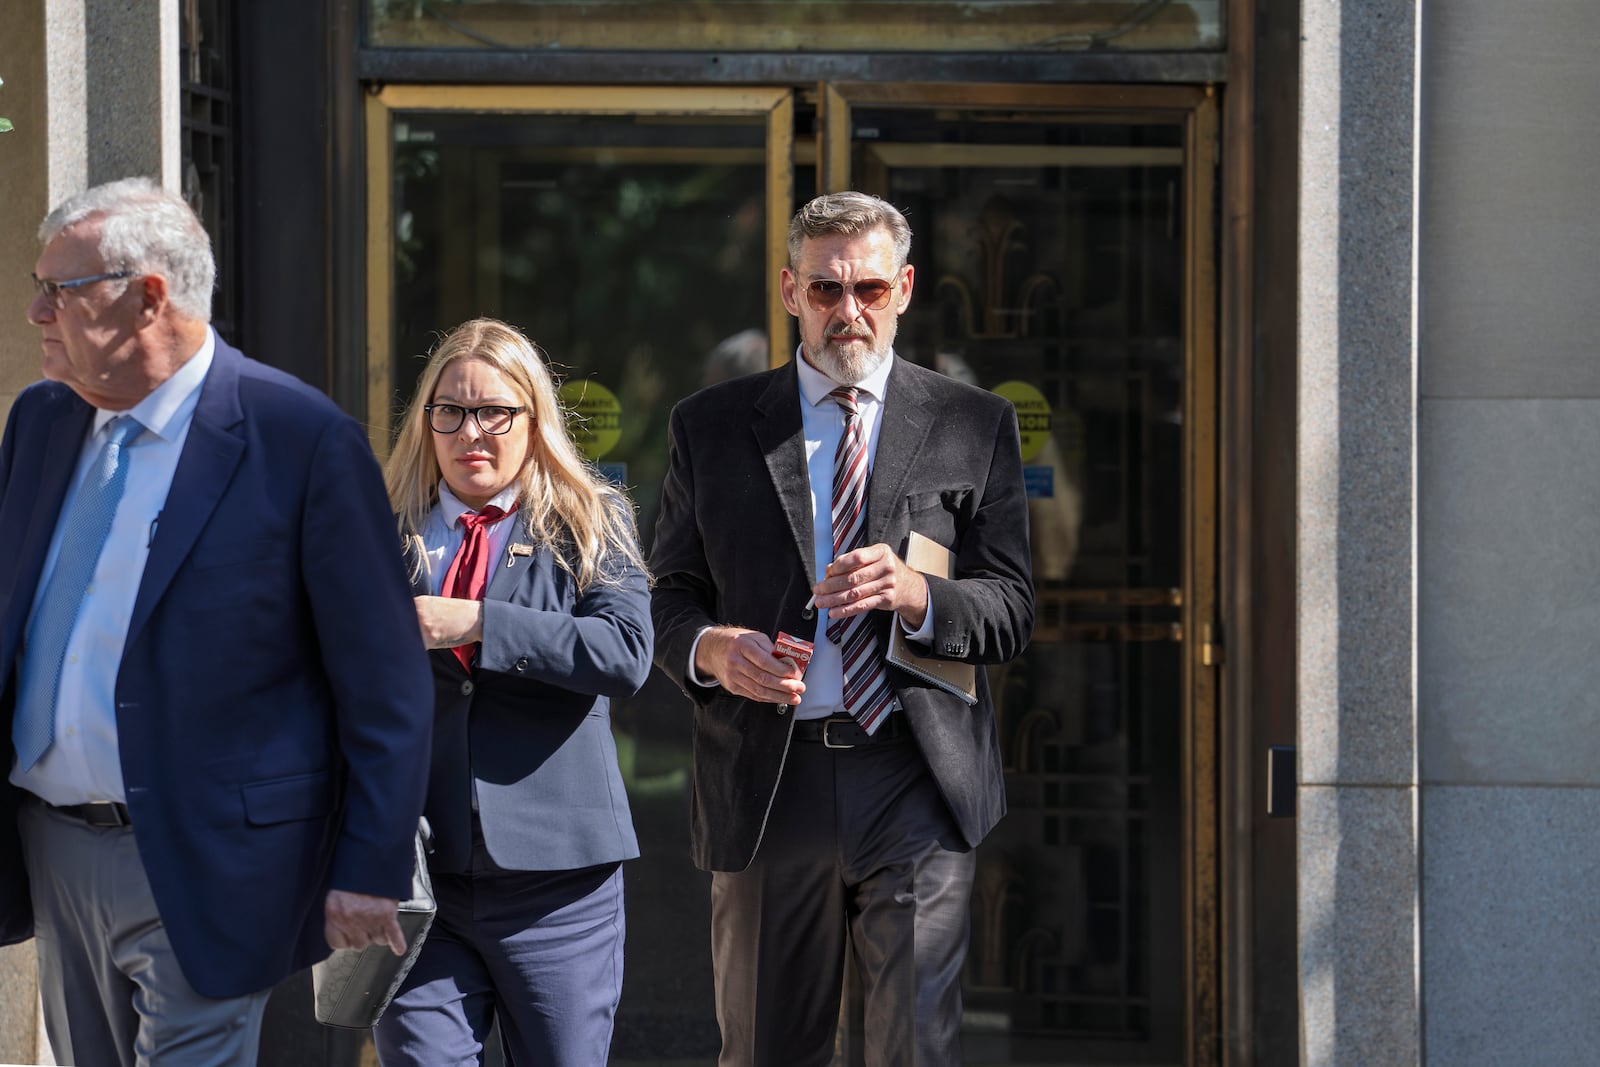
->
[712,737,978,1067]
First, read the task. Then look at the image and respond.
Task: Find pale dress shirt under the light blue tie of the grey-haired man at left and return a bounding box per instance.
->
[11,326,216,805]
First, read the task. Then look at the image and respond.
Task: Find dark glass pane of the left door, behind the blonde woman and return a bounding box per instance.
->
[392,112,768,1062]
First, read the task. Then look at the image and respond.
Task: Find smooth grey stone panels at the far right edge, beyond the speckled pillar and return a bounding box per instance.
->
[1418,0,1600,1067]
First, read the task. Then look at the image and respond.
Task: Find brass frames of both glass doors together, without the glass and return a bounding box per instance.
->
[365,83,1238,1067]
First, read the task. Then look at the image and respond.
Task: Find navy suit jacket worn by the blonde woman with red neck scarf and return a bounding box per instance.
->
[413,517,654,872]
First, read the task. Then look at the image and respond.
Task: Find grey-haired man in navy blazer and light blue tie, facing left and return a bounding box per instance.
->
[0,179,434,1067]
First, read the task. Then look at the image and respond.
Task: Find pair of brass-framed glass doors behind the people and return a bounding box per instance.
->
[366,85,1219,1067]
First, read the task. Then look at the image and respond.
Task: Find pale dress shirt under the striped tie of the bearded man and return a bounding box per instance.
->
[690,349,933,718]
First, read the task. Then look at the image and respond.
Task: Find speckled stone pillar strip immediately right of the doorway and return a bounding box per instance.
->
[1296,0,1422,1067]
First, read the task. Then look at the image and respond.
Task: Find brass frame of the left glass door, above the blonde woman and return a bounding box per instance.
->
[366,85,794,456]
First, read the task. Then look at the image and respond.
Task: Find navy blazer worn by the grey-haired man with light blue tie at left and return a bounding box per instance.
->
[0,341,432,997]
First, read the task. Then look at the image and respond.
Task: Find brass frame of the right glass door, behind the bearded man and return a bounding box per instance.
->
[818,82,1222,1067]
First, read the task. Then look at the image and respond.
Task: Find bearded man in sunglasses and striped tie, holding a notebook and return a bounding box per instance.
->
[650,192,1034,1067]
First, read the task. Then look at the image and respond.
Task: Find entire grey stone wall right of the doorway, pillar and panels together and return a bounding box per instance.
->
[1296,0,1600,1067]
